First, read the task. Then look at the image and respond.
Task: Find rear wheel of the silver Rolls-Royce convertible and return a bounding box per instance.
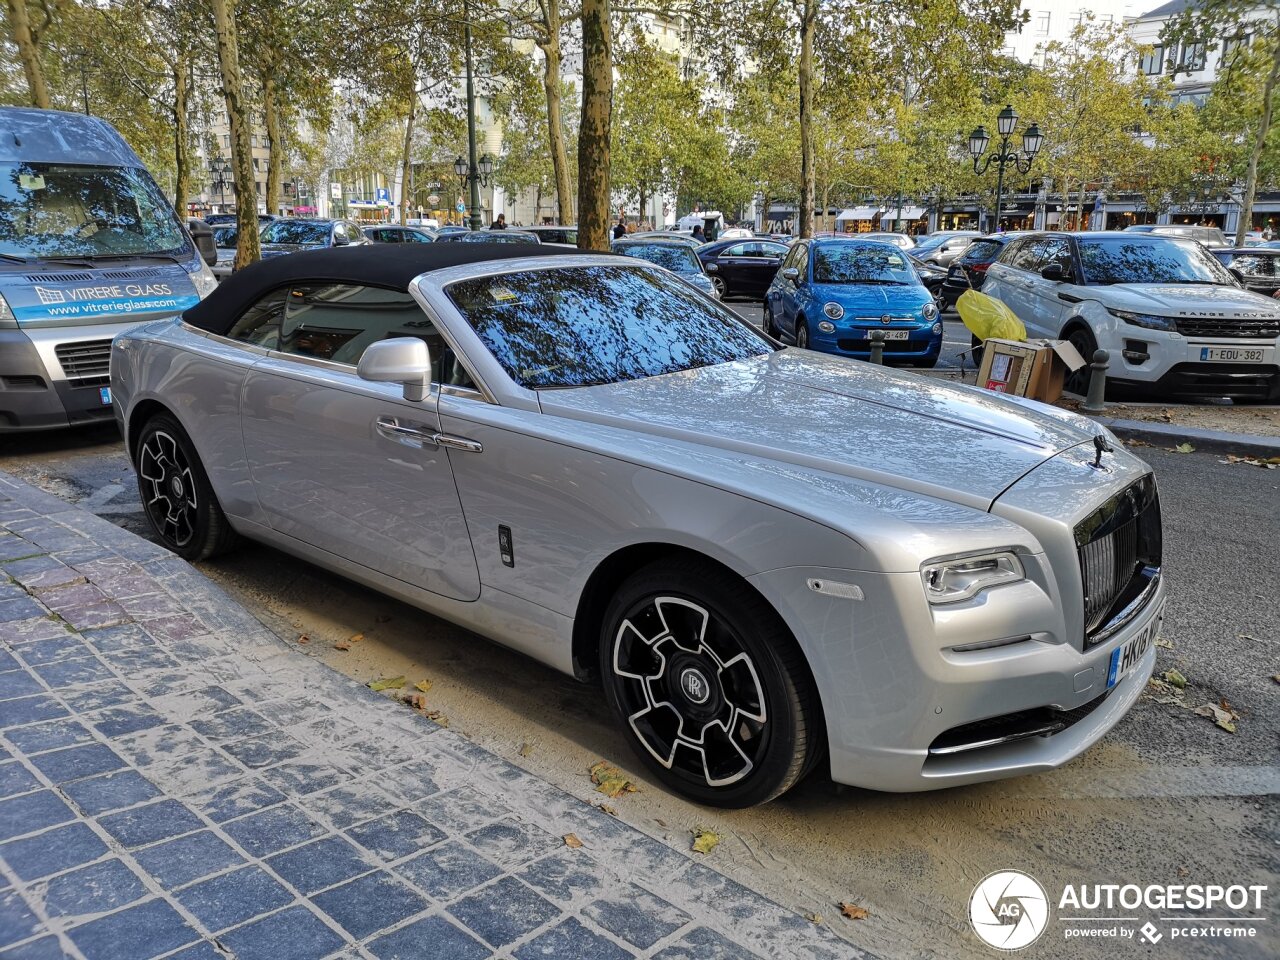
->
[133,413,236,561]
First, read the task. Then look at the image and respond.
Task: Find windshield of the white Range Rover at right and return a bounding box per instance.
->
[1078,233,1233,284]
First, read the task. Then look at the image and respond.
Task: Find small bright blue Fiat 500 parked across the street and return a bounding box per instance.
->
[764,237,942,366]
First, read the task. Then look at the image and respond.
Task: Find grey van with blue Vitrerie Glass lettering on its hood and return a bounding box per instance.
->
[0,108,216,434]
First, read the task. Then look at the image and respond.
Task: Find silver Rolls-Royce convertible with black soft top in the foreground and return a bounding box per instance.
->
[111,244,1166,806]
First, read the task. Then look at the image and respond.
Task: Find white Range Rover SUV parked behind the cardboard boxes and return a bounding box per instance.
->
[982,232,1280,402]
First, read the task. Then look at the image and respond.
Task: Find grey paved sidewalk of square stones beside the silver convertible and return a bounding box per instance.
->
[0,472,865,960]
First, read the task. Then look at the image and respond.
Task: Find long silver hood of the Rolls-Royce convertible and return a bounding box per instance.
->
[539,349,1101,509]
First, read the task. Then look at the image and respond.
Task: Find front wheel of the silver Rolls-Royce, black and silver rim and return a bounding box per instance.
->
[600,558,823,808]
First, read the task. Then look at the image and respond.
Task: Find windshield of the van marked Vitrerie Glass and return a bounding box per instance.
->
[0,163,189,259]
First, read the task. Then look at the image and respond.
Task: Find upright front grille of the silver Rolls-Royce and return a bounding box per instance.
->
[1075,475,1162,648]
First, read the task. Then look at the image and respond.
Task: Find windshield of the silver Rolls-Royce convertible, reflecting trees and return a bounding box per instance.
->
[447,266,773,390]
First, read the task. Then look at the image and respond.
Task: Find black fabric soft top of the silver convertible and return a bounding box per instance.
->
[182,243,588,334]
